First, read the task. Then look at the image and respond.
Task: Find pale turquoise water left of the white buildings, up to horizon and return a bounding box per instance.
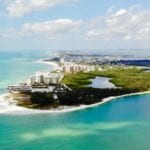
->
[0,52,54,93]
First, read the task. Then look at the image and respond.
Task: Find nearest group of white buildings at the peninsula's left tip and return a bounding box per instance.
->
[8,72,64,92]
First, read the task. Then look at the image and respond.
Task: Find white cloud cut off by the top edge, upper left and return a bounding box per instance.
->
[6,0,72,17]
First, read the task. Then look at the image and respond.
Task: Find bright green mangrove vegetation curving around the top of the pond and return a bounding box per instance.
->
[62,68,150,91]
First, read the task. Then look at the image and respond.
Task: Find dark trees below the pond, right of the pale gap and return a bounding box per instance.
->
[58,87,137,106]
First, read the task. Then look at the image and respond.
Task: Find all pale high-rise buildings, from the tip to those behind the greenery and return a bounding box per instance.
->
[8,59,102,92]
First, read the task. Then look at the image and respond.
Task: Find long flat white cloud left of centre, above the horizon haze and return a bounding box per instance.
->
[5,19,82,39]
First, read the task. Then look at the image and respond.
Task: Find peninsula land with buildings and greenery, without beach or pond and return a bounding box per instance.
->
[8,53,150,110]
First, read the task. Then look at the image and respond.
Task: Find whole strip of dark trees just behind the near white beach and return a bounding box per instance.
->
[18,87,137,109]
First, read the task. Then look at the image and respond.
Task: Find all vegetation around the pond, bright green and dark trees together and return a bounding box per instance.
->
[15,68,150,109]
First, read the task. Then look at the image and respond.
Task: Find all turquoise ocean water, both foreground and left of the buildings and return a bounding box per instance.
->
[0,53,150,150]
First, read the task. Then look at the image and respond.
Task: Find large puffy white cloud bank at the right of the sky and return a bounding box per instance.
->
[87,6,150,40]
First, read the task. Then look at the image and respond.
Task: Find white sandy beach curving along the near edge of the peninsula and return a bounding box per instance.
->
[0,91,150,115]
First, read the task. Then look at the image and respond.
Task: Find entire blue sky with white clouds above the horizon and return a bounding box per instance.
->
[0,0,150,51]
